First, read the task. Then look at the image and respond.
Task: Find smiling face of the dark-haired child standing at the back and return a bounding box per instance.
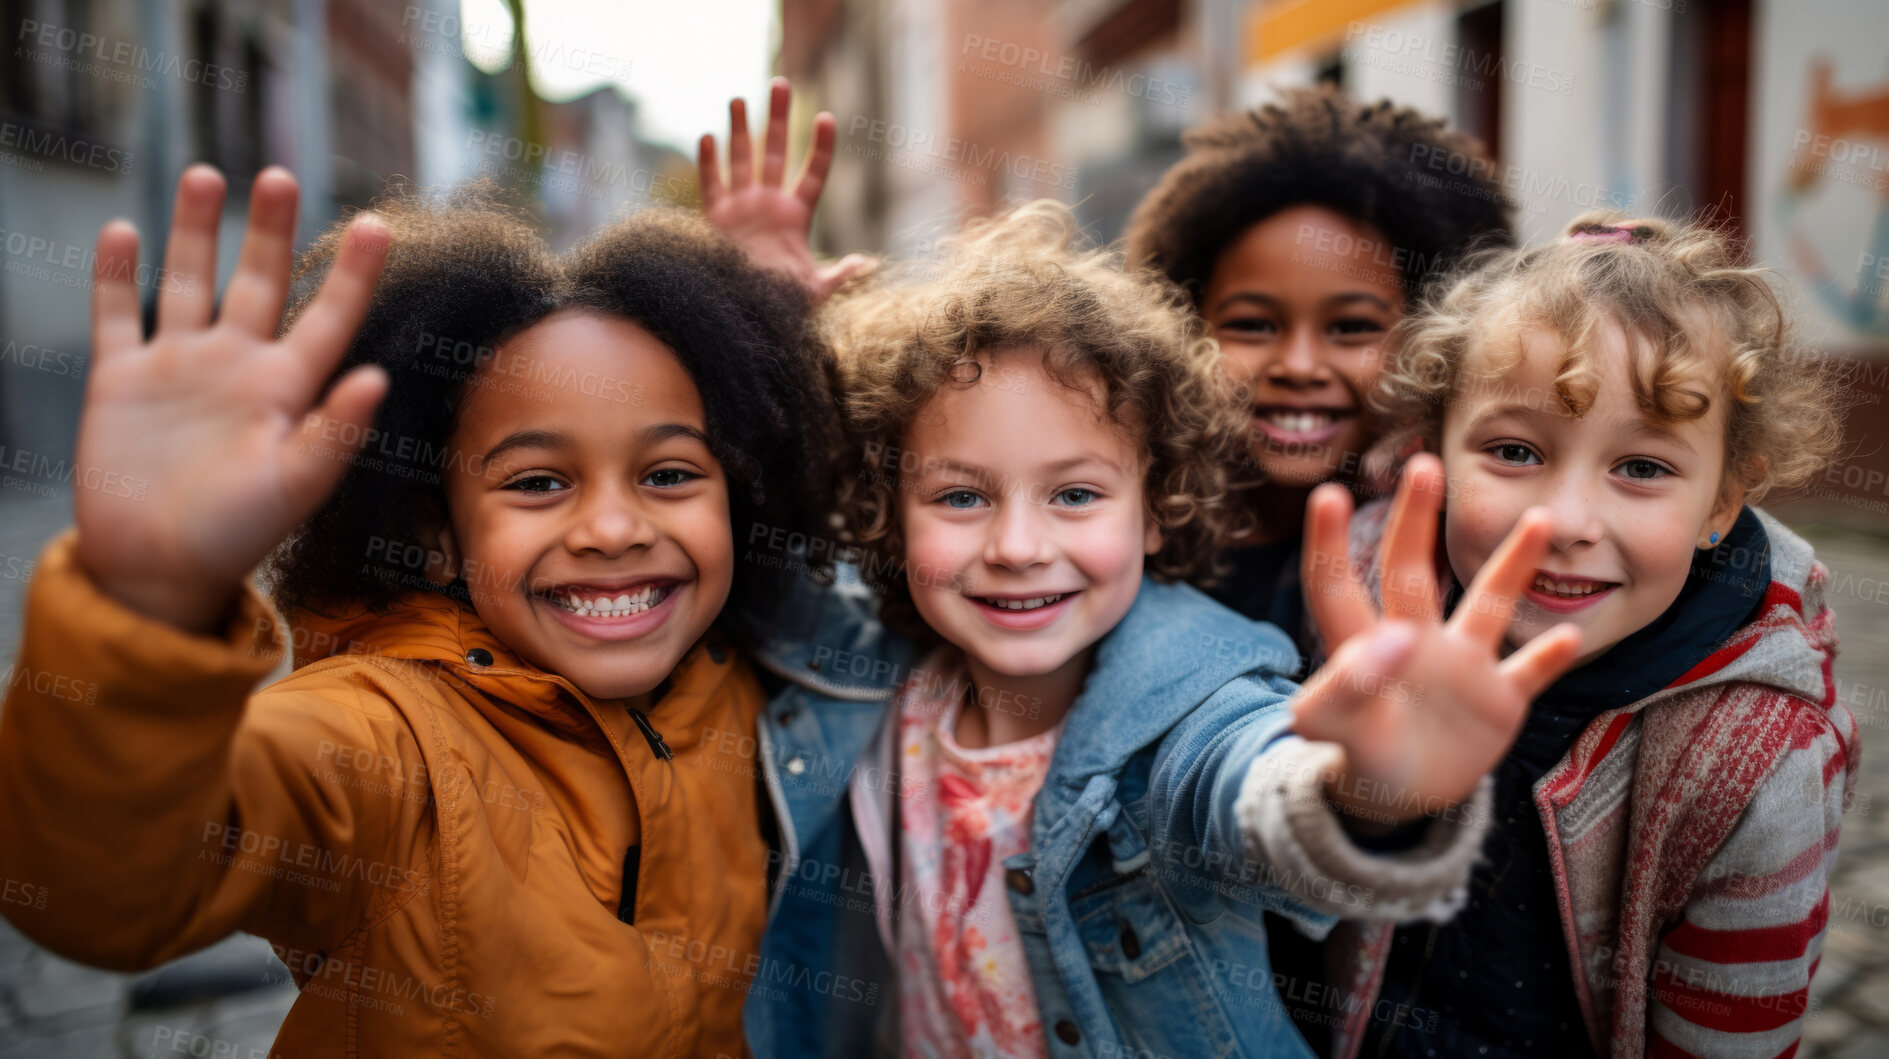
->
[1201,206,1404,487]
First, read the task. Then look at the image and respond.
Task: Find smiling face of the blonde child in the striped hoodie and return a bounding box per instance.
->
[1441,323,1744,663]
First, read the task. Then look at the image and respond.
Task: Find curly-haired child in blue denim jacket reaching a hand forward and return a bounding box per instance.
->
[729,202,1577,1055]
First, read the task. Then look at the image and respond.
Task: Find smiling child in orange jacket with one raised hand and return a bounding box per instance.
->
[0,166,829,1055]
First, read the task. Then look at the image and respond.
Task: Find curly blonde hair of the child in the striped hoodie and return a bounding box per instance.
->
[1371,211,1842,502]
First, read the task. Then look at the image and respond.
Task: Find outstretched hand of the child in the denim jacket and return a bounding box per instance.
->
[1292,455,1581,827]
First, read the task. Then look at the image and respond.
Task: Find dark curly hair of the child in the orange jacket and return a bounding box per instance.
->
[264,181,839,612]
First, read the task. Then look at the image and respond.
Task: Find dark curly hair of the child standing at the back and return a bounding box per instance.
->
[1126,87,1513,304]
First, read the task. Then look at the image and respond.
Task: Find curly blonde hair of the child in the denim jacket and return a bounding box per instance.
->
[822,200,1249,611]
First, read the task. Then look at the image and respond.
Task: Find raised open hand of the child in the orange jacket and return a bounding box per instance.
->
[74,166,389,632]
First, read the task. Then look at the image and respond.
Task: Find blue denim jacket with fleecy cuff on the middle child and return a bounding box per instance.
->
[746,572,1489,1059]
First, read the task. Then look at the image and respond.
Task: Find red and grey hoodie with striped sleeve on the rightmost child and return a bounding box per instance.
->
[1326,508,1859,1059]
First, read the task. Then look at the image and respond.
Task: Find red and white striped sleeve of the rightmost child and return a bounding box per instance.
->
[1647,704,1857,1059]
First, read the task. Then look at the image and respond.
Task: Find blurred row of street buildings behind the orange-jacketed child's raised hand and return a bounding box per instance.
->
[0,0,693,462]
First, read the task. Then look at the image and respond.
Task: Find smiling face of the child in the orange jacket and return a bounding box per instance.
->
[440,311,735,698]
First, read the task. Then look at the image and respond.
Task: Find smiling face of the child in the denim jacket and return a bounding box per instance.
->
[899,349,1162,683]
